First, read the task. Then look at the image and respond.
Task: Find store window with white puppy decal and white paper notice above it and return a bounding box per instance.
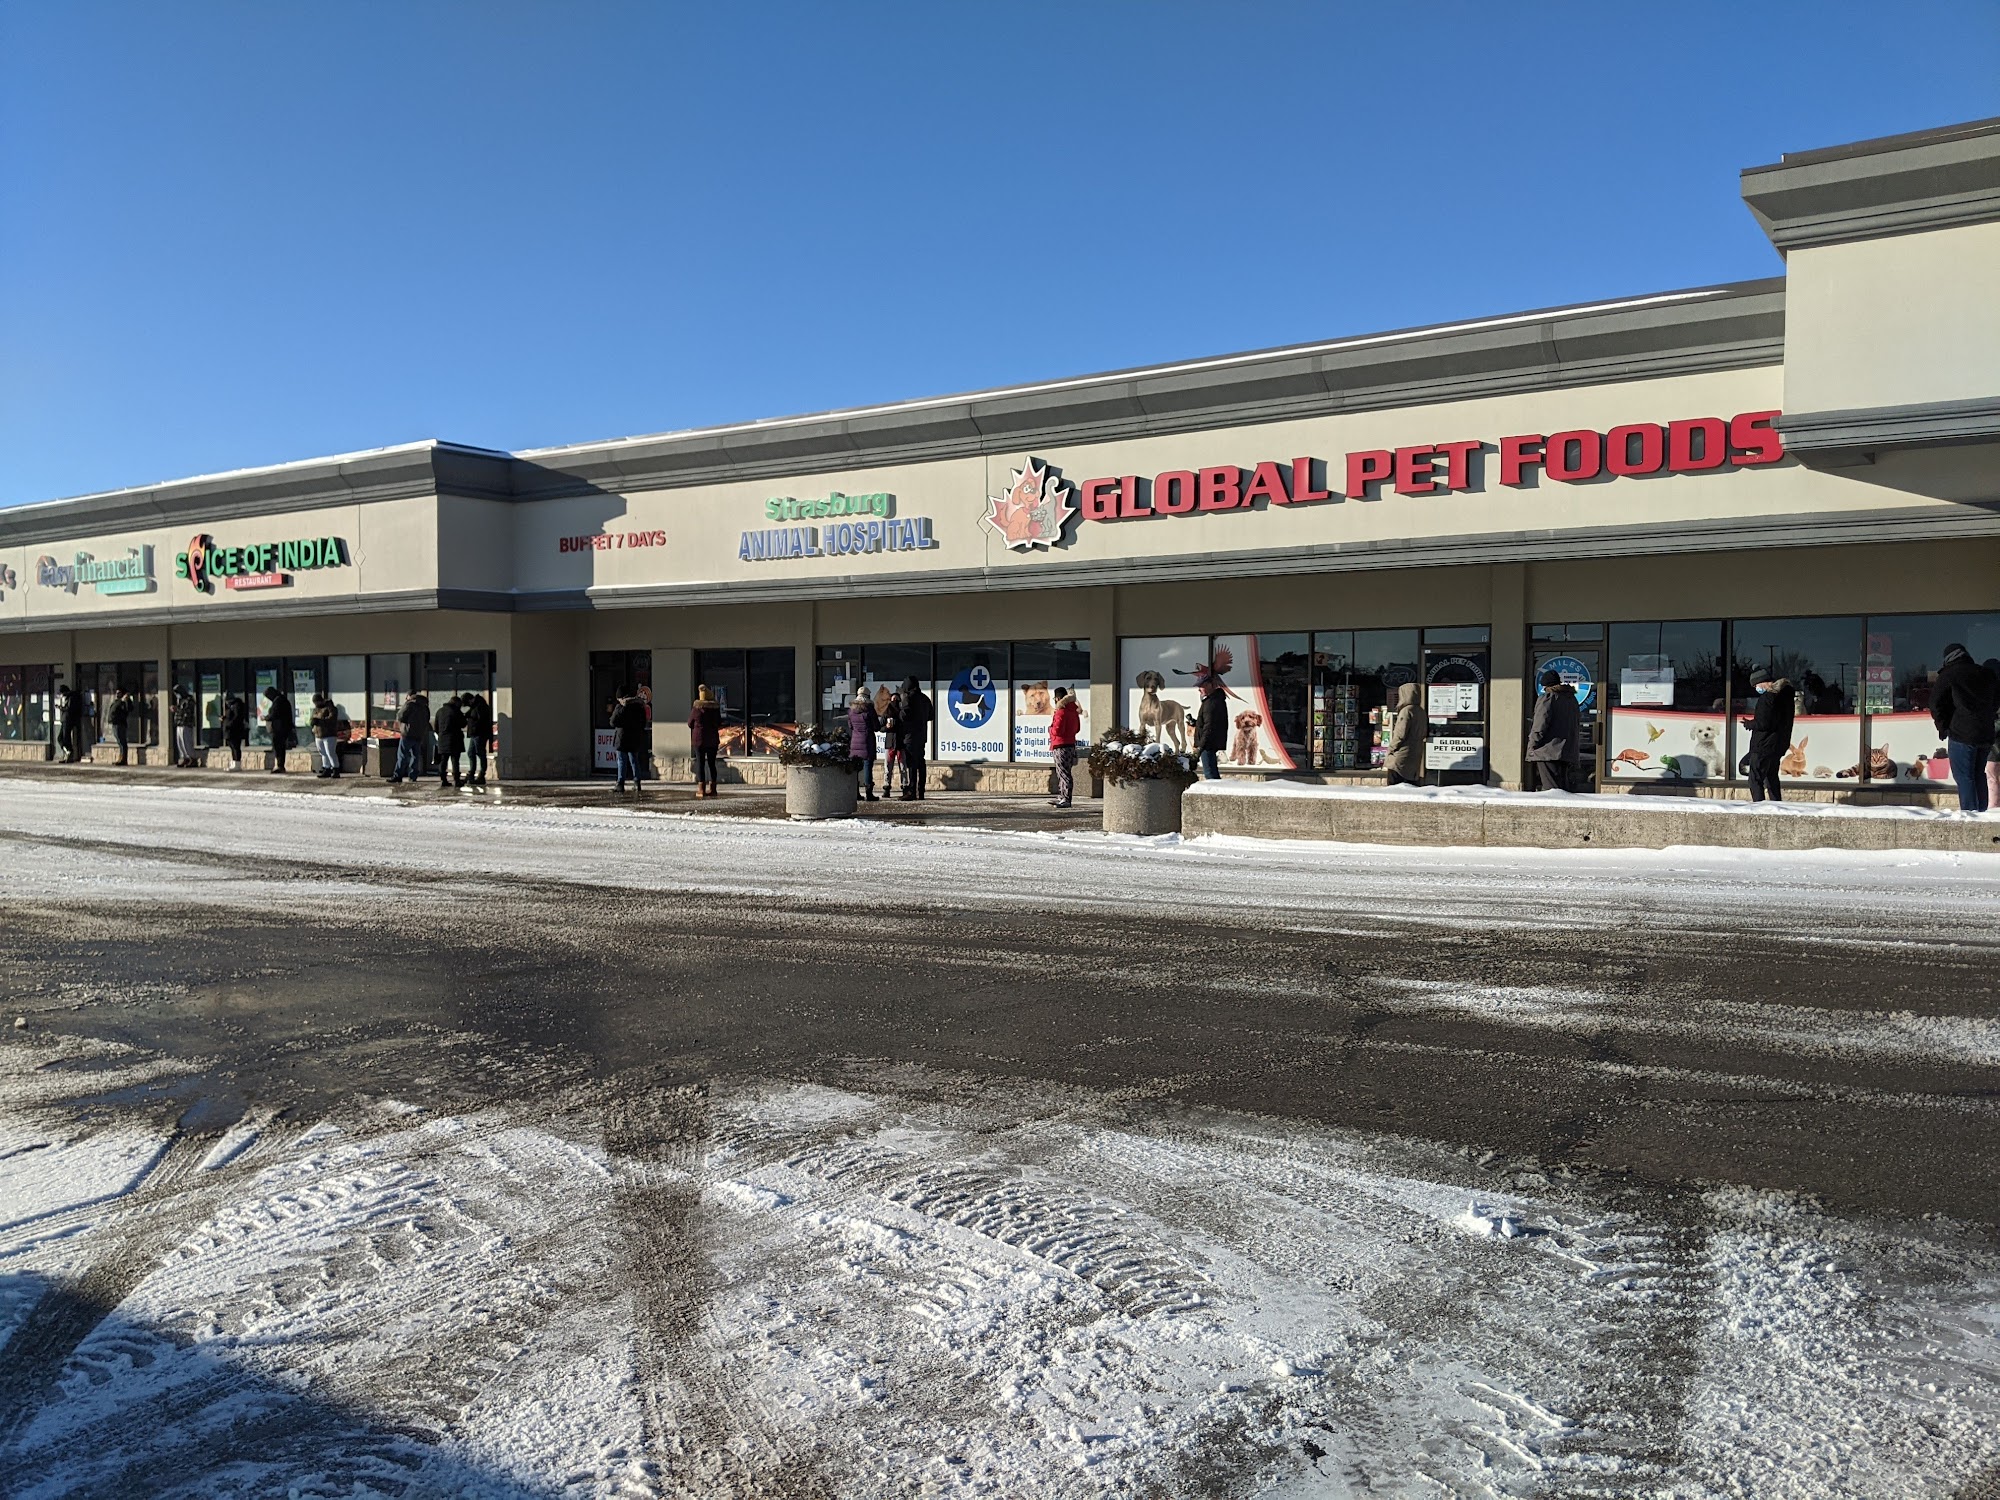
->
[1602,620,1730,782]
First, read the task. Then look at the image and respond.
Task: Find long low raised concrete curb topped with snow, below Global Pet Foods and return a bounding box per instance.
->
[1182,782,2000,854]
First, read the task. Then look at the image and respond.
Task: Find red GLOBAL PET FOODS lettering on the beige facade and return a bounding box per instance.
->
[1076,412,1784,520]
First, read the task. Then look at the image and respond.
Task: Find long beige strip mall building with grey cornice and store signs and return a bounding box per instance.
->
[0,122,2000,794]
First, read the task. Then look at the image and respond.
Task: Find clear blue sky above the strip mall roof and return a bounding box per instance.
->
[0,0,2000,504]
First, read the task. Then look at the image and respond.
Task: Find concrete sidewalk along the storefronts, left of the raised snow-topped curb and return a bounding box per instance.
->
[0,756,1102,832]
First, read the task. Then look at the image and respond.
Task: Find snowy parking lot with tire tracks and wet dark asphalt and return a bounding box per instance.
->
[0,778,2000,1498]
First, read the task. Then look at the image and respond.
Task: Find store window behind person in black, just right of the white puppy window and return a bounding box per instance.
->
[1730,616,1866,782]
